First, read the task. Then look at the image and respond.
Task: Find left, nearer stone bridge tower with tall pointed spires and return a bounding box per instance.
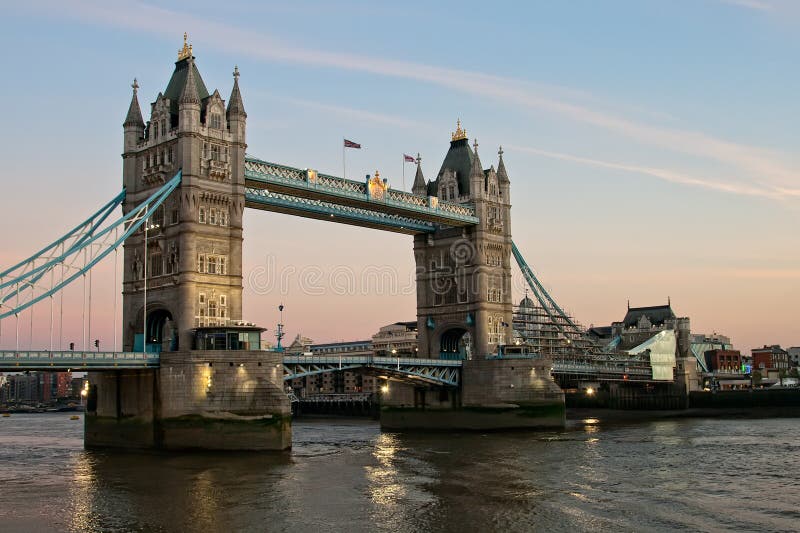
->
[122,34,247,351]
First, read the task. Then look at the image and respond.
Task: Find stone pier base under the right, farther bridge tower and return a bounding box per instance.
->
[381,359,566,431]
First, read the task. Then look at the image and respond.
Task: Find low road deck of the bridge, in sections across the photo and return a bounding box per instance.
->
[0,351,654,387]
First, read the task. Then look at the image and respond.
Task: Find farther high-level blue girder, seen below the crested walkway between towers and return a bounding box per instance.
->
[245,187,436,235]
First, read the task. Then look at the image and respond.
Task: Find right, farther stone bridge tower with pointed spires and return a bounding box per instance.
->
[412,121,512,358]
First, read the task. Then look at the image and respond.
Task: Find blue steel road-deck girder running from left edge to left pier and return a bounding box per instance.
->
[0,351,160,372]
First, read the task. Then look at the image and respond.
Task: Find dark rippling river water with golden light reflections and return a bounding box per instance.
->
[0,414,800,532]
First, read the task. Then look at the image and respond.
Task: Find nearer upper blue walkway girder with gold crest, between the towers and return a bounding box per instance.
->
[245,156,478,226]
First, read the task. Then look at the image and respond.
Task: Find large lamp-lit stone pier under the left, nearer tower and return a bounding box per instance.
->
[84,351,292,450]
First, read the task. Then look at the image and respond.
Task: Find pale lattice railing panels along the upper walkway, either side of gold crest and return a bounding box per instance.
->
[244,156,476,223]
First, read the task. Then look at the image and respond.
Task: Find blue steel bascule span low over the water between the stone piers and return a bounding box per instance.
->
[283,355,461,387]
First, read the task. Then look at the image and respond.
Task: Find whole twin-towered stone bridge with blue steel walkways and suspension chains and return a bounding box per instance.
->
[0,34,688,449]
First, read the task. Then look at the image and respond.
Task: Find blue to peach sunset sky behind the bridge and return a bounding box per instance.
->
[0,0,800,352]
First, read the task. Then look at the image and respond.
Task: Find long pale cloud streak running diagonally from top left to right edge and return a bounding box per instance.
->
[20,0,800,202]
